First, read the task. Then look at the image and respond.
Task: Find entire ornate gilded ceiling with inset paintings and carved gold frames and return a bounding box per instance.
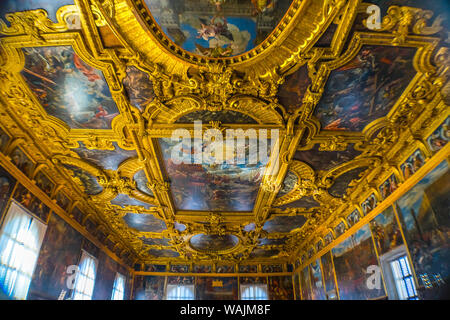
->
[0,0,450,271]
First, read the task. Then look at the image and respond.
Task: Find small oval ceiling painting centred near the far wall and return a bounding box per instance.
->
[190,233,239,252]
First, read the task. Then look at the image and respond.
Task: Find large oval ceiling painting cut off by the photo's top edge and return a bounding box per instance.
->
[143,0,292,58]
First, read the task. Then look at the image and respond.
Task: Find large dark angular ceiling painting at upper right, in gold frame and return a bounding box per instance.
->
[315,46,416,131]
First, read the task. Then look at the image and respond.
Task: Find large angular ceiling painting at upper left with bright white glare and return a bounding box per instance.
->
[22,46,119,129]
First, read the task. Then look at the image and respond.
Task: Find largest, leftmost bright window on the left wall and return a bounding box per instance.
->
[0,202,47,299]
